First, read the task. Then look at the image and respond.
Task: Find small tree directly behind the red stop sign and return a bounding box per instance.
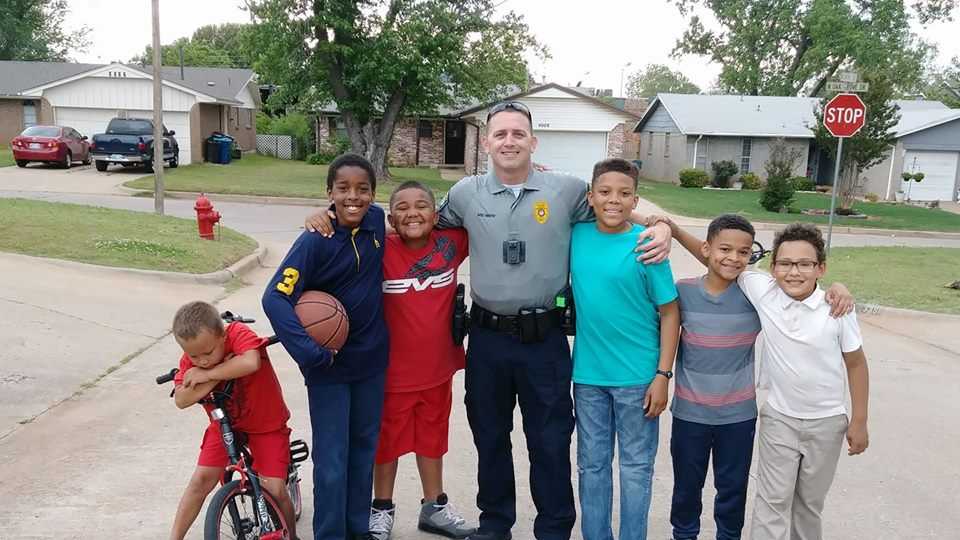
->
[812,75,900,210]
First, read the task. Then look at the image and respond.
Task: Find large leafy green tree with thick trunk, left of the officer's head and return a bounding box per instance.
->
[248,0,546,176]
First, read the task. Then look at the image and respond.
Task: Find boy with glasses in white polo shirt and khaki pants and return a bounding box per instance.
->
[737,223,869,540]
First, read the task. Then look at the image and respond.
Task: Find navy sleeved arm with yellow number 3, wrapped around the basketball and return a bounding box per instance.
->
[262,233,334,369]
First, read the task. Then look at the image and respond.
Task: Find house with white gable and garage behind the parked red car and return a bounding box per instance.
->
[0,61,261,165]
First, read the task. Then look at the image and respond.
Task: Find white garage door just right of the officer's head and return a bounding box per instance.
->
[533,131,607,181]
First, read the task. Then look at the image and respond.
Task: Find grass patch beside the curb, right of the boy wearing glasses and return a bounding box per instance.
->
[761,247,960,314]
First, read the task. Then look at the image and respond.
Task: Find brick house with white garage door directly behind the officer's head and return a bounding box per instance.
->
[316,83,646,178]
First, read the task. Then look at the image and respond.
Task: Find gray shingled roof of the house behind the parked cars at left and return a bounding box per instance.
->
[0,61,253,102]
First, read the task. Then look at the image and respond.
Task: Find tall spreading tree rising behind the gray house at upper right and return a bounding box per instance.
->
[672,0,956,96]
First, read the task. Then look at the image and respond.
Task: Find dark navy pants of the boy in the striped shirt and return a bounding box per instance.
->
[670,418,757,540]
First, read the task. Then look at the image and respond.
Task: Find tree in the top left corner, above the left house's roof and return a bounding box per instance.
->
[0,0,90,62]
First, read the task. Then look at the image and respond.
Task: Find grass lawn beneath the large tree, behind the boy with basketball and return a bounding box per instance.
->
[124,154,453,202]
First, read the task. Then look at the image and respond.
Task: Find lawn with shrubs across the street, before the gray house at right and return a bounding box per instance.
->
[639,181,960,232]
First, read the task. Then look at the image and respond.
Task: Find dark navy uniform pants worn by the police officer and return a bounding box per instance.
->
[465,327,576,540]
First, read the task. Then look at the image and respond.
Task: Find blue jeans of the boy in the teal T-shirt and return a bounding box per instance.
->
[573,384,660,540]
